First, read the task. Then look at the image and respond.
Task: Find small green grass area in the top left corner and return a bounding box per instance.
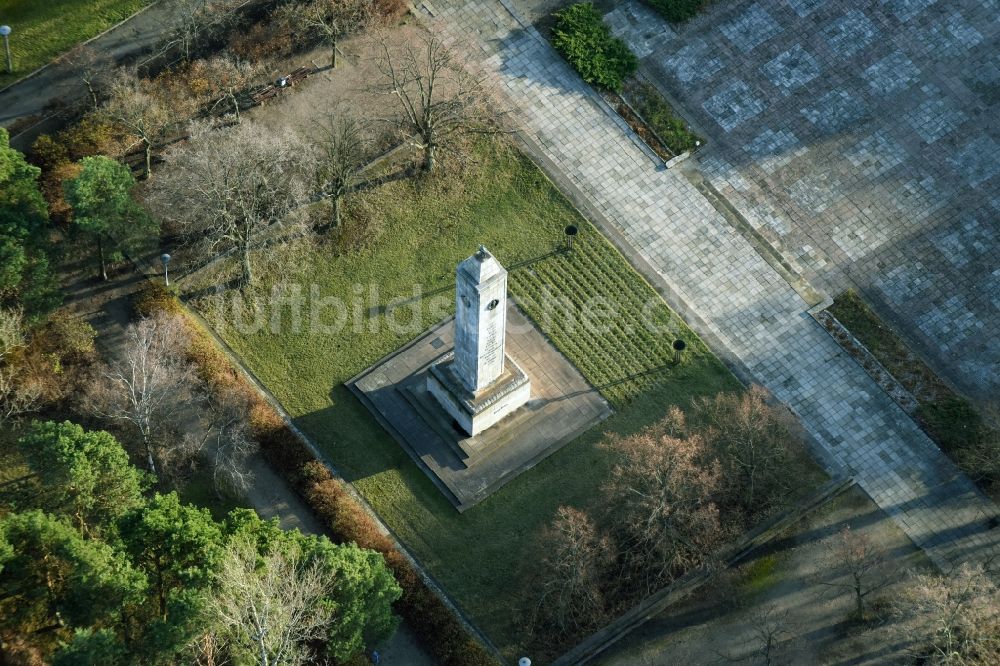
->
[0,0,151,88]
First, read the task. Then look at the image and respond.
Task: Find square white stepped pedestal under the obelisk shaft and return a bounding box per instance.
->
[427,353,531,437]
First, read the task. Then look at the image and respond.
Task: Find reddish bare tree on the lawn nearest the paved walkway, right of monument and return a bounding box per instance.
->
[694,386,796,516]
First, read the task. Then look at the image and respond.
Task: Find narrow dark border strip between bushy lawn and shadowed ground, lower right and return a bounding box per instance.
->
[552,477,856,666]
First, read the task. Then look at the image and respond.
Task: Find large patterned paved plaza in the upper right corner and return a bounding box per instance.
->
[609,0,1000,398]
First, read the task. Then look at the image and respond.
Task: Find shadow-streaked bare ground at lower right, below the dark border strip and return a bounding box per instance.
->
[597,487,929,666]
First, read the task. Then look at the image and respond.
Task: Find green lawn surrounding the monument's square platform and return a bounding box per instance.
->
[188,143,740,656]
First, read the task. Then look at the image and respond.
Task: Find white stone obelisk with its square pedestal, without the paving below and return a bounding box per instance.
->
[427,246,531,435]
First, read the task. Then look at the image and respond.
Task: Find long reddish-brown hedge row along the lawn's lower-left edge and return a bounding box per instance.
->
[136,283,497,666]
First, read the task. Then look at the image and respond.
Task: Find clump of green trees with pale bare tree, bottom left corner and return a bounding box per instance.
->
[0,421,401,666]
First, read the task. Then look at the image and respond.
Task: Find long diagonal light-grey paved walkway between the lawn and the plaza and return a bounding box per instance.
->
[420,0,1000,568]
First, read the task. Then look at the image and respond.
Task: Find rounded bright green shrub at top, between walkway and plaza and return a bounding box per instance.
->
[552,2,639,91]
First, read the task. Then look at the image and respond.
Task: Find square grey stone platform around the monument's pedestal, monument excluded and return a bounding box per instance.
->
[347,300,612,511]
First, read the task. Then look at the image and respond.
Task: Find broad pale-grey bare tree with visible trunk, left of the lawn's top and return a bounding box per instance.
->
[149,122,312,287]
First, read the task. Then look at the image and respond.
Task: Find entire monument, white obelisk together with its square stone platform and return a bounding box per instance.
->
[347,247,611,511]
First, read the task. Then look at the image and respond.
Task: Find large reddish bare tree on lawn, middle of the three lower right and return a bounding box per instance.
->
[605,426,724,592]
